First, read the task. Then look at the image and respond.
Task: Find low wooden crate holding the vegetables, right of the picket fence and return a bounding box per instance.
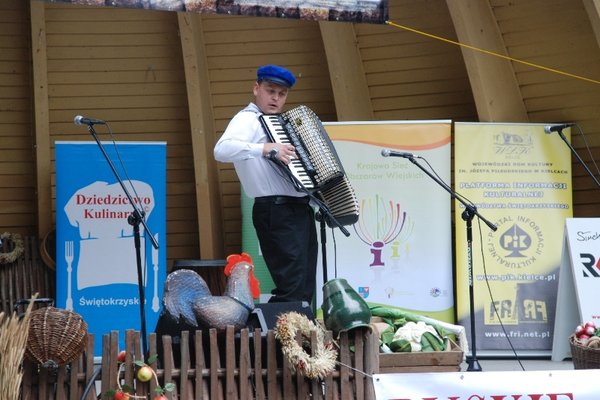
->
[379,341,463,374]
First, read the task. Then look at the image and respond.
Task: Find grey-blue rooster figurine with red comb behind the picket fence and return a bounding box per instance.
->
[162,253,260,330]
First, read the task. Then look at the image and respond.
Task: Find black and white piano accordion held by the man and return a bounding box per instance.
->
[259,105,359,226]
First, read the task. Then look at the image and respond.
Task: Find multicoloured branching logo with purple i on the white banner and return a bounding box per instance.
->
[353,195,410,267]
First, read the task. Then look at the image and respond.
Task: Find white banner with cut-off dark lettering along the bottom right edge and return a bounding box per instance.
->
[373,369,600,400]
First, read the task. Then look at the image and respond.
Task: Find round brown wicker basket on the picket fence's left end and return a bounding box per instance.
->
[25,307,88,366]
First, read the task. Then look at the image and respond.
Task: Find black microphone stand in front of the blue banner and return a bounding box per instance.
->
[88,123,158,358]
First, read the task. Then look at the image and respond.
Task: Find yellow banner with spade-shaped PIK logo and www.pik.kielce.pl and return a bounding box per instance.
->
[454,123,572,351]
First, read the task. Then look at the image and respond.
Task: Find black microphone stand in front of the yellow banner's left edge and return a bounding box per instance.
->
[406,155,498,371]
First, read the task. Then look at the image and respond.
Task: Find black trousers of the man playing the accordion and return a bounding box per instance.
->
[252,196,318,304]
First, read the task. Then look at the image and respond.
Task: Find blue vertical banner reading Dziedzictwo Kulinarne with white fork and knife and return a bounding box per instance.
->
[55,142,167,356]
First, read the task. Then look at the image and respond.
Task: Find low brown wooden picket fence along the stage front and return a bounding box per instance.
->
[22,328,379,400]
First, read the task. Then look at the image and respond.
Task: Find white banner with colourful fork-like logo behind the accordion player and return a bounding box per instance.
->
[242,120,454,322]
